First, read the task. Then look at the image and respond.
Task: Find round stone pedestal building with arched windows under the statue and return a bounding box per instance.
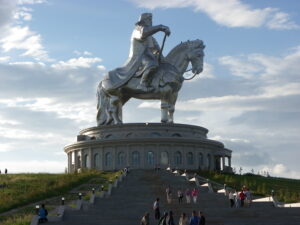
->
[64,123,231,172]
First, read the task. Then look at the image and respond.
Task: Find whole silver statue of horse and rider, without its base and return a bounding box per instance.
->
[97,13,205,126]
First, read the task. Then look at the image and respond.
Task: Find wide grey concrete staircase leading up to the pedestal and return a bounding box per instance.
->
[51,170,300,225]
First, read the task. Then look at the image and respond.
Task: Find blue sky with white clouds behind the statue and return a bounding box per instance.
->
[0,0,300,178]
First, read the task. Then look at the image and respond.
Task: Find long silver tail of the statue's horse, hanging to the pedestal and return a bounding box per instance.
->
[96,82,109,126]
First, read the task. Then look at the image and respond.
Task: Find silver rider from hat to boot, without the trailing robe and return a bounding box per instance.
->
[129,13,171,92]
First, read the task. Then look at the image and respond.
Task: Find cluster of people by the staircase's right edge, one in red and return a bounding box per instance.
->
[228,186,252,208]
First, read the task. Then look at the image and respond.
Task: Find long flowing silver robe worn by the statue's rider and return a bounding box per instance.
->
[102,25,159,90]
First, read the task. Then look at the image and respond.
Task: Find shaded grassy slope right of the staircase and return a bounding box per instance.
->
[199,171,300,203]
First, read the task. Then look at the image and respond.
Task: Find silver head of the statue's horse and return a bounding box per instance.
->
[187,40,205,74]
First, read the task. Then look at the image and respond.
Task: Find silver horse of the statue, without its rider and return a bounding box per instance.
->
[97,40,205,126]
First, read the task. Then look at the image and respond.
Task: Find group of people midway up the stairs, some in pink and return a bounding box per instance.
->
[166,186,199,204]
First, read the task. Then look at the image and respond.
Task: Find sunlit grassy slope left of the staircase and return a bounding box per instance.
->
[0,171,120,216]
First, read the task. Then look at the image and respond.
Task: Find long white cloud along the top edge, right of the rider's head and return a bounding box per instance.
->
[131,0,299,29]
